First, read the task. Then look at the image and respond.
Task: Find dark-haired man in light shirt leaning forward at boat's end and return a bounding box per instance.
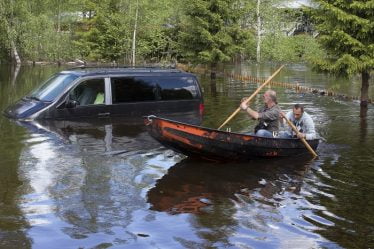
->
[279,104,317,140]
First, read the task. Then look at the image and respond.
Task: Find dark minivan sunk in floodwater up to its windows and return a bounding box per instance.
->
[4,67,204,120]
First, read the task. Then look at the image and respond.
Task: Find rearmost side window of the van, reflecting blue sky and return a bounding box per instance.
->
[157,77,198,100]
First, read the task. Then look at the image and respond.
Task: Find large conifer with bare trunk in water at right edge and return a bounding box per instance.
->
[310,0,374,106]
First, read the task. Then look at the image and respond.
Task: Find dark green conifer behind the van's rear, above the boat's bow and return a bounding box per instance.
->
[179,0,248,77]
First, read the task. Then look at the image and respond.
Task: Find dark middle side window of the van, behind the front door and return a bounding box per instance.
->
[111,77,156,104]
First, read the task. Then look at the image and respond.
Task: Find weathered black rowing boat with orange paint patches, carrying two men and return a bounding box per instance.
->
[144,116,319,161]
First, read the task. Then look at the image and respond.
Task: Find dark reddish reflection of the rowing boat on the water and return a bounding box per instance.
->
[147,157,311,214]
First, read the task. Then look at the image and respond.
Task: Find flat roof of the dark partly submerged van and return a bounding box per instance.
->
[61,67,193,76]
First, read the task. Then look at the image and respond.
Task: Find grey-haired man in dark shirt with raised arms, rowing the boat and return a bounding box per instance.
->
[240,90,281,137]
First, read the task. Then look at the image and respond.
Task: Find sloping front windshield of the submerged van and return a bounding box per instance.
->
[27,74,78,102]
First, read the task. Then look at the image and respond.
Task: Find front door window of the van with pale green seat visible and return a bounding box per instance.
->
[70,79,105,106]
